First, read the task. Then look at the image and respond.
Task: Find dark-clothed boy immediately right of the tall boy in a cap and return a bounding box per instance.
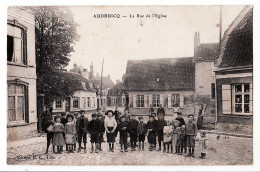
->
[88,113,100,153]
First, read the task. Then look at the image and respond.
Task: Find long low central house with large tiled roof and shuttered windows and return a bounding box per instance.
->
[124,57,195,115]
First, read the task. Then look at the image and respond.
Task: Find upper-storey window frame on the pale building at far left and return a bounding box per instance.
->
[7,19,28,66]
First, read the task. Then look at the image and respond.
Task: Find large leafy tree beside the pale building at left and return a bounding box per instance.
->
[34,6,79,104]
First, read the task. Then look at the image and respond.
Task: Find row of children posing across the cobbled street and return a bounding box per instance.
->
[44,110,208,158]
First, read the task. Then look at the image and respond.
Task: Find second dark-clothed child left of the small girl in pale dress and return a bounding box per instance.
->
[147,115,157,151]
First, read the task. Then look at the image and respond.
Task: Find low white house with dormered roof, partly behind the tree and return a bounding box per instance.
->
[53,72,97,114]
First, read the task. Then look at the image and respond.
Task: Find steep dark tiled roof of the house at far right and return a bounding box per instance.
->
[216,6,253,68]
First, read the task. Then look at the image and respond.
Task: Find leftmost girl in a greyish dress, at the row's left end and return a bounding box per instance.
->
[52,115,65,154]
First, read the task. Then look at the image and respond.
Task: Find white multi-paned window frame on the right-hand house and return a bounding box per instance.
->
[231,83,252,115]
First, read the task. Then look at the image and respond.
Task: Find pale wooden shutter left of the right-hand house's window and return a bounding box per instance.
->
[222,85,232,114]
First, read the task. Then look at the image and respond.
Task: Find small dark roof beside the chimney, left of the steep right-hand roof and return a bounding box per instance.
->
[196,43,219,61]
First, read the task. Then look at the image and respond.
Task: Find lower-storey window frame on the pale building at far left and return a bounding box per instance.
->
[7,79,29,126]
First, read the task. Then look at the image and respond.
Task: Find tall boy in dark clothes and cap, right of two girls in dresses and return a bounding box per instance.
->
[76,110,89,153]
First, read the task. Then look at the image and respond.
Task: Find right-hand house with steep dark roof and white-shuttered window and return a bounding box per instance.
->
[215,6,253,125]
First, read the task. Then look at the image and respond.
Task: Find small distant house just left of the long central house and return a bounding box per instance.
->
[107,81,127,107]
